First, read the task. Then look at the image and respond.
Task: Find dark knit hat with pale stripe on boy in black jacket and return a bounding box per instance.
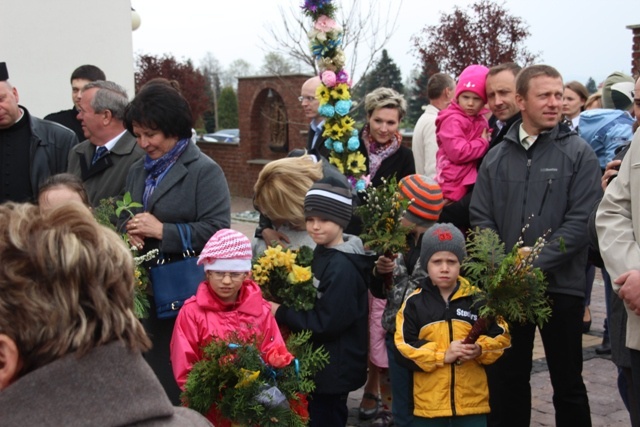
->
[304,177,353,229]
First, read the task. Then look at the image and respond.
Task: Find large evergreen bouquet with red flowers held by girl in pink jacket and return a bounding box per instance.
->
[182,331,329,427]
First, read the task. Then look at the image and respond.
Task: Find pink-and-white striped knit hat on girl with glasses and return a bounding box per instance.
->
[198,228,252,271]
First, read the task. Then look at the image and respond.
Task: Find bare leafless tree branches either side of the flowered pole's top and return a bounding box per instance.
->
[265,0,403,86]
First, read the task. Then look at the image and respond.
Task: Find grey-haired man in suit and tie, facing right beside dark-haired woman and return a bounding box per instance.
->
[69,81,144,207]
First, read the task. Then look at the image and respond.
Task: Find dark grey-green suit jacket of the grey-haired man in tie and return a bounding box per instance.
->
[68,132,144,207]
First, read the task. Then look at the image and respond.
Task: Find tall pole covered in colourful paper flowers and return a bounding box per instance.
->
[302,0,368,190]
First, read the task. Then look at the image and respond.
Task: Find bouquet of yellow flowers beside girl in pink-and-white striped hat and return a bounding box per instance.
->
[252,245,316,310]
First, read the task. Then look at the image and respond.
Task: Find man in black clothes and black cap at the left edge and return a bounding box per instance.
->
[0,62,78,203]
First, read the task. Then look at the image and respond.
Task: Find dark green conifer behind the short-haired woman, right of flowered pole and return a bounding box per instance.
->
[352,49,404,122]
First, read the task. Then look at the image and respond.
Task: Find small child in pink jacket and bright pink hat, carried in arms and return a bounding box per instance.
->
[436,65,489,204]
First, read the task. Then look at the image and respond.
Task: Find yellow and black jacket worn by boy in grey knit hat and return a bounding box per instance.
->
[395,277,511,418]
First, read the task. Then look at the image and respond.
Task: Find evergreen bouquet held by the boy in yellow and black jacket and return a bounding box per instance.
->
[462,226,562,344]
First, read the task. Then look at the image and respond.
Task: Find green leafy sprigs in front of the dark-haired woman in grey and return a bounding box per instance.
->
[93,192,159,319]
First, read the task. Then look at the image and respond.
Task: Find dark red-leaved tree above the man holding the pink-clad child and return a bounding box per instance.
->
[413,0,538,77]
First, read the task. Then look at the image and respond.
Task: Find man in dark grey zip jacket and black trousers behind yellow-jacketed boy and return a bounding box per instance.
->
[470,65,602,427]
